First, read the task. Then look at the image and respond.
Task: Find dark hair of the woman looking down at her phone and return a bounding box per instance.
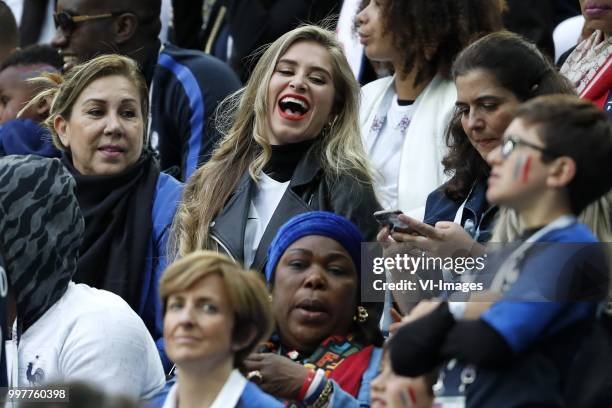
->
[442,31,575,201]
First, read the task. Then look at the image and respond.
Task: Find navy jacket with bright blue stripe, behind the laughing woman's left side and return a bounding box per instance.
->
[144,45,241,181]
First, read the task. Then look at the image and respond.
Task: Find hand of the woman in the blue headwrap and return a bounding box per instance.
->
[244,353,308,400]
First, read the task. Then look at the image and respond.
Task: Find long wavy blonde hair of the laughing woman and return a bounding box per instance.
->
[169,25,371,258]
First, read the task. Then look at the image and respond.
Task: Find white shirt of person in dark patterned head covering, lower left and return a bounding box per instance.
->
[6,282,165,399]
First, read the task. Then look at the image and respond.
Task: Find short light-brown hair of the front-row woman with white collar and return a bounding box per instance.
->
[159,251,274,367]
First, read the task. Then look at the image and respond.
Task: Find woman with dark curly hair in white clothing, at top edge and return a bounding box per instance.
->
[357,0,502,220]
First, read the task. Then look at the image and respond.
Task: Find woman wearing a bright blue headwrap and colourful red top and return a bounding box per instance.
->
[245,211,382,407]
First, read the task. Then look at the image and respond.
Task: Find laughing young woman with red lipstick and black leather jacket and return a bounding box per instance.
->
[173,26,379,270]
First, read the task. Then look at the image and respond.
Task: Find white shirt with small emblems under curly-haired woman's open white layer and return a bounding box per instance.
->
[369,97,413,209]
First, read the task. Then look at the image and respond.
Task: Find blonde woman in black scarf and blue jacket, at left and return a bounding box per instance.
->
[26,55,182,368]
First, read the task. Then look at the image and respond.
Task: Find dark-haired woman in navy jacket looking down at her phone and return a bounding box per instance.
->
[379,31,573,279]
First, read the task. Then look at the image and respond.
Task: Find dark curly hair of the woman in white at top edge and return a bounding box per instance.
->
[383,0,504,85]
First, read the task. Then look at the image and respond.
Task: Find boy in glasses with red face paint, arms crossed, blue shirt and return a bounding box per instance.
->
[391,95,612,407]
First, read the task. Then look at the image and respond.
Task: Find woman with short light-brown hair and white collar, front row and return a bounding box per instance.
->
[160,251,282,408]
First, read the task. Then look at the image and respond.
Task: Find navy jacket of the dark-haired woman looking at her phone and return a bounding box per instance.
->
[423,180,497,243]
